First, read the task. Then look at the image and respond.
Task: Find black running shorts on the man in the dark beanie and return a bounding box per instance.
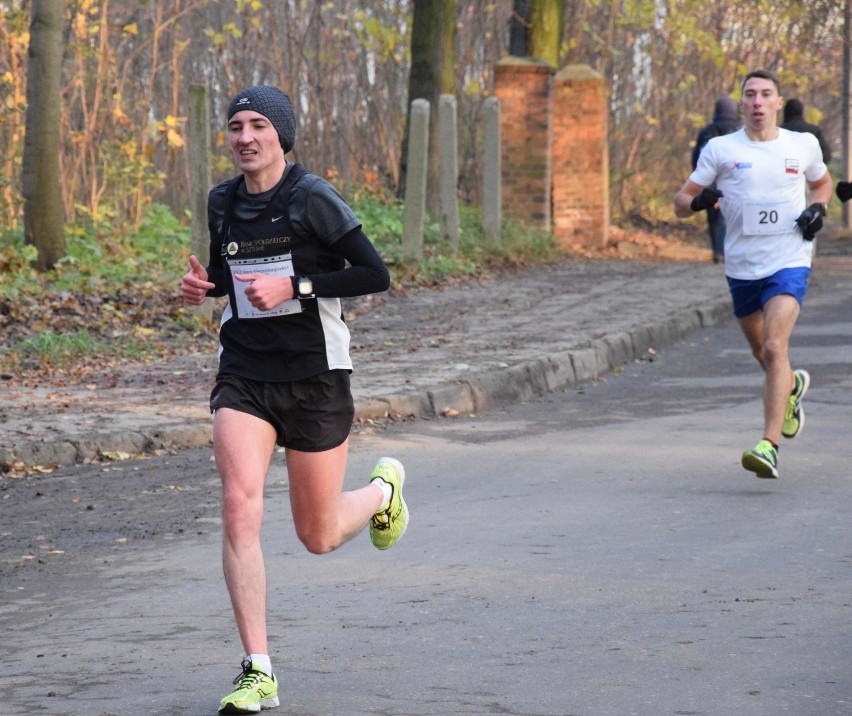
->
[210,370,355,452]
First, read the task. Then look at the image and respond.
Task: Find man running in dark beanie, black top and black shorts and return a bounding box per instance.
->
[181,86,408,713]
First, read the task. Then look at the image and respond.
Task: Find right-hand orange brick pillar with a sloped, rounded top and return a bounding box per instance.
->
[552,65,609,247]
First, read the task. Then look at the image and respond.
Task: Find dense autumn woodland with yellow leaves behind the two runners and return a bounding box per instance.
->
[0,0,843,242]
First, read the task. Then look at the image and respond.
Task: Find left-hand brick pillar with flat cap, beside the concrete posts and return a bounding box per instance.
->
[494,57,554,231]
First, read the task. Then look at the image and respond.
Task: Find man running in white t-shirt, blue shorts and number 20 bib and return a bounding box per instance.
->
[674,70,832,477]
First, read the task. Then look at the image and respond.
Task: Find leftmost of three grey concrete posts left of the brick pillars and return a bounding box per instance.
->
[402,99,429,259]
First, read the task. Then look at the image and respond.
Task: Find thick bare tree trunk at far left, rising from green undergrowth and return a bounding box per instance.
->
[22,0,65,270]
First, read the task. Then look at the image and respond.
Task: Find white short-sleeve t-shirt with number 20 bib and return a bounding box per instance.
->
[690,127,826,280]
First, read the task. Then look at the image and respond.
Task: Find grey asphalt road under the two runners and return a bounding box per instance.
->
[0,264,852,716]
